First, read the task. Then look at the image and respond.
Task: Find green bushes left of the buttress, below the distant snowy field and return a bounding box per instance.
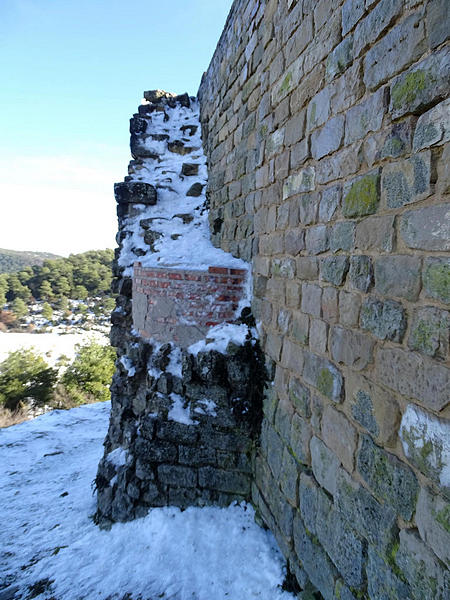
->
[0,342,116,418]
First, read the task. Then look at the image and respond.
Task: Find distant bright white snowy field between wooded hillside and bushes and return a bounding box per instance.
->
[0,331,109,365]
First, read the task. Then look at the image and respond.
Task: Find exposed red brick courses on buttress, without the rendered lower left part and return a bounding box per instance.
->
[133,262,247,337]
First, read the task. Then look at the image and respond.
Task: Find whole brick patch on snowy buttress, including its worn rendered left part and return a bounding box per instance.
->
[133,263,247,348]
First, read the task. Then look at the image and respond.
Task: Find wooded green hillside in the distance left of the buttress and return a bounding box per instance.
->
[0,250,114,304]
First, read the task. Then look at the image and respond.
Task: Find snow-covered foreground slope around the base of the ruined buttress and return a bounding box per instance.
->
[0,402,293,600]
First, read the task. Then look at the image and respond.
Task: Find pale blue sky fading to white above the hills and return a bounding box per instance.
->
[0,0,232,254]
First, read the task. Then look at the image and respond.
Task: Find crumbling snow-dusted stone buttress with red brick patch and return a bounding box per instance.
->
[95,91,265,527]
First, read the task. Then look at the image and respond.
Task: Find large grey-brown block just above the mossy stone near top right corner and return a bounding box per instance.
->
[362,11,426,89]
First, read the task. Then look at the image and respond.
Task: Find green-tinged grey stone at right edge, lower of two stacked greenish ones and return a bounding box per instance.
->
[408,306,450,360]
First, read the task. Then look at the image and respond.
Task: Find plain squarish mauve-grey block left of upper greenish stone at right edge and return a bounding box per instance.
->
[375,254,423,302]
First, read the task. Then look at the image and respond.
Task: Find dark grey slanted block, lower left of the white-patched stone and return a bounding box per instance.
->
[357,436,419,521]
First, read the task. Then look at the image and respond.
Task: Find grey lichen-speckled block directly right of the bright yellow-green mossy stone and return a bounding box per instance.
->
[381,151,431,208]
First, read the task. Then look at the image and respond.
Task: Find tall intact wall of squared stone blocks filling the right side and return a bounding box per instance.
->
[199,0,450,600]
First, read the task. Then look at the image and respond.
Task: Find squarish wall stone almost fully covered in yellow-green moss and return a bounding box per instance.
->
[342,169,380,217]
